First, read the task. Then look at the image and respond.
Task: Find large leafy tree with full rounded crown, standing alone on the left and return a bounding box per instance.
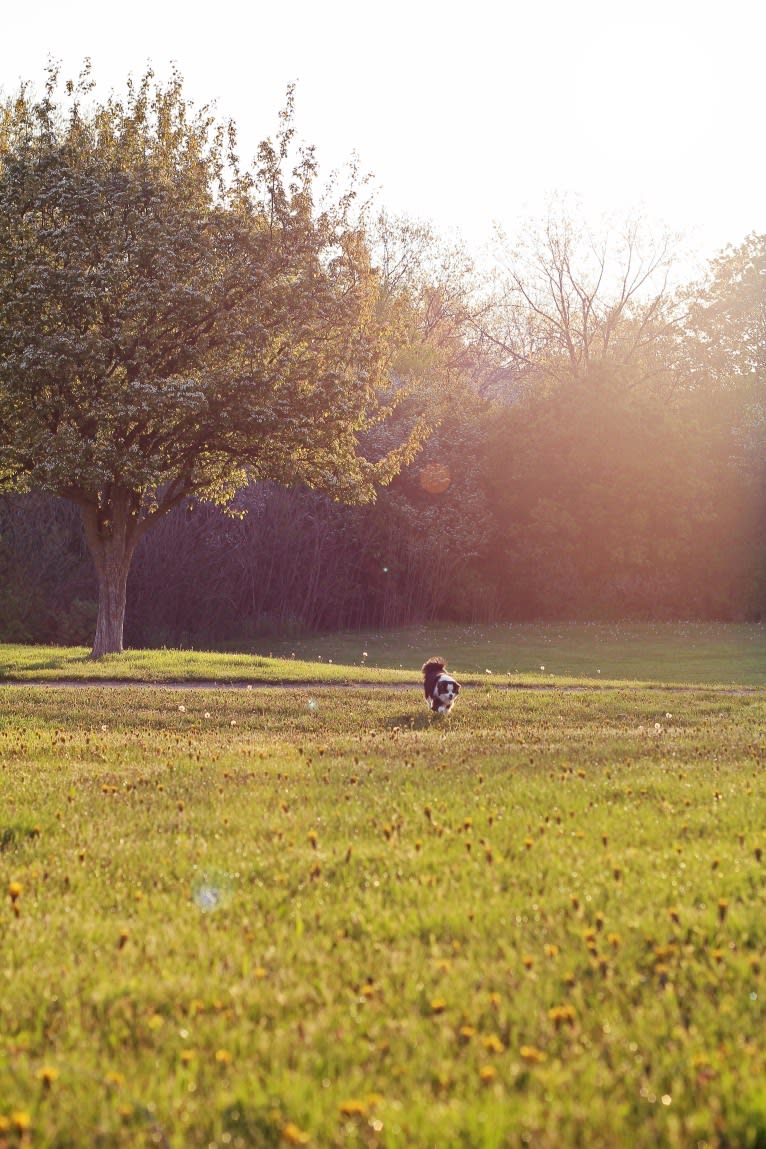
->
[0,68,418,657]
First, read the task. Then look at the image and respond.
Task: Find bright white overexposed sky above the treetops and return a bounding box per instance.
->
[0,0,766,273]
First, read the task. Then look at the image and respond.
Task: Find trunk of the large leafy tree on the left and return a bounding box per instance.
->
[80,491,142,658]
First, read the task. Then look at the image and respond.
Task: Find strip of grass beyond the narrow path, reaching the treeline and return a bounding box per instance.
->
[0,623,766,686]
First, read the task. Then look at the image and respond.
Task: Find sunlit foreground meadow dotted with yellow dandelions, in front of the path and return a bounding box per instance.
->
[0,675,766,1149]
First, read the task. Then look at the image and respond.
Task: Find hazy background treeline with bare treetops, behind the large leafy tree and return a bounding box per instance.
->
[0,203,766,646]
